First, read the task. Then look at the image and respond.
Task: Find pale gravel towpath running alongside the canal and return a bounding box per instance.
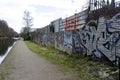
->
[1,40,79,80]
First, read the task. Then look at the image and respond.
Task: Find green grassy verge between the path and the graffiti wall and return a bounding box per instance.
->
[25,41,118,80]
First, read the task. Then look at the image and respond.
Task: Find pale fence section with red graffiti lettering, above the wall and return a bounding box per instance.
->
[64,10,87,30]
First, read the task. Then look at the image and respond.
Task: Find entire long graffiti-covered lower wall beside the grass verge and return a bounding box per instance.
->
[30,13,120,61]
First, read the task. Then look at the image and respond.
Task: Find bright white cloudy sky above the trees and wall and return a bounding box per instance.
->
[0,0,87,33]
